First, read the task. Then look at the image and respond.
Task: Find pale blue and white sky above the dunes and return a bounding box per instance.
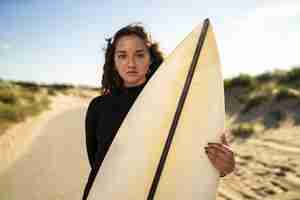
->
[0,0,300,86]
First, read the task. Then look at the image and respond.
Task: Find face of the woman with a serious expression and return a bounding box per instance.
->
[114,35,151,87]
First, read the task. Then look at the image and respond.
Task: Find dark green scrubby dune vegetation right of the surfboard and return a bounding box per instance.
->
[224,68,300,138]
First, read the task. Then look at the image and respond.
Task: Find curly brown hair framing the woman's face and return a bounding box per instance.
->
[101,23,163,94]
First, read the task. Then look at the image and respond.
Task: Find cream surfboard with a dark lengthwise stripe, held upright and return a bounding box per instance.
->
[88,19,225,200]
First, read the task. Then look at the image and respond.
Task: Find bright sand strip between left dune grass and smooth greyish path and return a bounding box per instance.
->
[0,95,89,174]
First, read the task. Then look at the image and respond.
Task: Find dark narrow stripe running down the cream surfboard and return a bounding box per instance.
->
[147,19,209,200]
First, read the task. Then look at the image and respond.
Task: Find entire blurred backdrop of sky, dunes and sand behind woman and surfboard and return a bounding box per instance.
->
[0,0,300,200]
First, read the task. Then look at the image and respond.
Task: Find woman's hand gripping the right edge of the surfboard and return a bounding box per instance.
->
[205,132,235,177]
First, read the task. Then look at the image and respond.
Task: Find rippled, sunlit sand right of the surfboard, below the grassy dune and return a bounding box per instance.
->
[217,126,300,200]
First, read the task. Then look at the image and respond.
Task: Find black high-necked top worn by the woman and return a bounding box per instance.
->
[85,83,146,171]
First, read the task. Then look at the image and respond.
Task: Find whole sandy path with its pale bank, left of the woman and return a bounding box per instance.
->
[0,96,95,200]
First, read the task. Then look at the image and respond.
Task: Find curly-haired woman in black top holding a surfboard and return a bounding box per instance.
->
[83,25,235,199]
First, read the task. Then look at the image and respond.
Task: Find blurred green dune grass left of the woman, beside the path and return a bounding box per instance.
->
[0,79,96,135]
